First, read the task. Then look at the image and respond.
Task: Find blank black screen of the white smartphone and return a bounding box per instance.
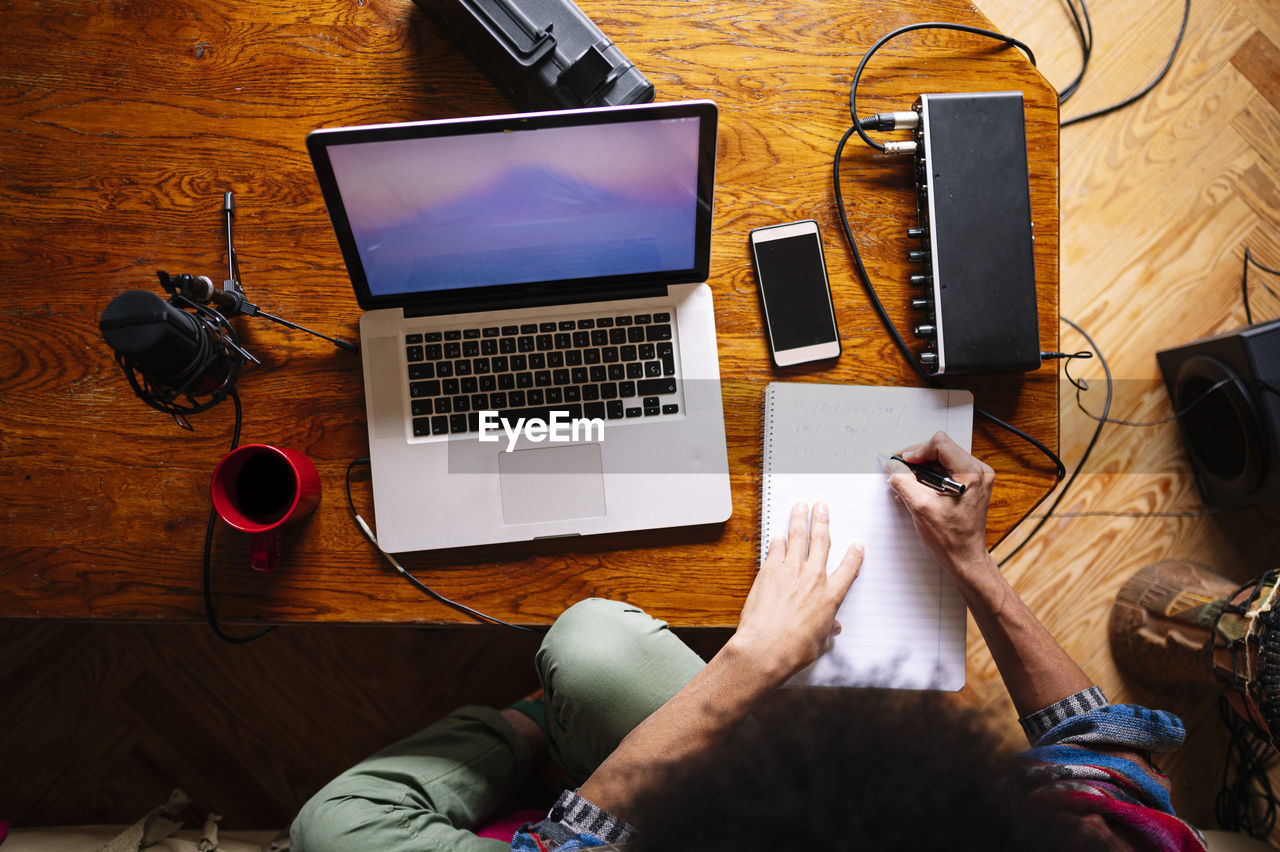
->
[754,232,837,352]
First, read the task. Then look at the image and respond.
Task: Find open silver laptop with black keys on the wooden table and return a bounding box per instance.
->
[307,101,732,553]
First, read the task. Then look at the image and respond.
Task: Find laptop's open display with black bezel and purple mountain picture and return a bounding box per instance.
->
[307,102,716,307]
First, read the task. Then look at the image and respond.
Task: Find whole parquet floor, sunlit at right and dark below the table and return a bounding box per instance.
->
[0,0,1280,828]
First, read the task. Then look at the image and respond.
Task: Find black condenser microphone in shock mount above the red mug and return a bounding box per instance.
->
[99,290,247,427]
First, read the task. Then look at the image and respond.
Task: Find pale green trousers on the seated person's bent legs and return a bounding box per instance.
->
[291,599,703,852]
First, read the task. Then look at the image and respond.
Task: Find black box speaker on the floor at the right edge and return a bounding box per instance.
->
[1156,320,1280,507]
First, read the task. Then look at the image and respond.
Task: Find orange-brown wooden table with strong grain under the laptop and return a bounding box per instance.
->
[0,0,1059,626]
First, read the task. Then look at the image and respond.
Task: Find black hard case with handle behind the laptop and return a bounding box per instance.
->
[415,0,654,111]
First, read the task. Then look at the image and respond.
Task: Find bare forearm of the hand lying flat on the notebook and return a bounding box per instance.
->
[577,637,788,821]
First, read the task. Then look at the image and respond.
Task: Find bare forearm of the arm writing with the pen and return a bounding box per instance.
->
[952,555,1093,716]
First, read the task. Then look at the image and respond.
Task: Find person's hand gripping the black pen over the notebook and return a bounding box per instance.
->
[886,432,996,574]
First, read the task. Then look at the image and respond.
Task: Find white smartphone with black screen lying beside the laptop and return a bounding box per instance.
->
[749,219,840,367]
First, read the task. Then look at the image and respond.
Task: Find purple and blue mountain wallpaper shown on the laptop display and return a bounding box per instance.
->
[329,118,699,296]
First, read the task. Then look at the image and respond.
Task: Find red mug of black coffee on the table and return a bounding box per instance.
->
[211,444,320,573]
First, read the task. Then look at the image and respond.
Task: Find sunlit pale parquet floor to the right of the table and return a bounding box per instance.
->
[969,0,1280,826]
